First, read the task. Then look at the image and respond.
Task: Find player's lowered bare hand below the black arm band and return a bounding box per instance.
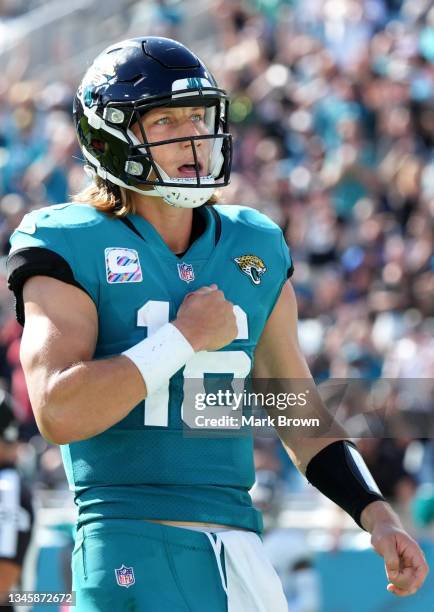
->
[371,522,429,597]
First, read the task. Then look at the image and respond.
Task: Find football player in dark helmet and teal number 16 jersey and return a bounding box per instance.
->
[8,37,427,612]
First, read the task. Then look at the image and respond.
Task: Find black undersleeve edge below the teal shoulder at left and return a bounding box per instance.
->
[6,247,93,325]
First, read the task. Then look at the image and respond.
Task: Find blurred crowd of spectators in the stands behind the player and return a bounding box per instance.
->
[0,0,434,580]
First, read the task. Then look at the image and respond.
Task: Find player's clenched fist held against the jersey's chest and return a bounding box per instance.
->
[173,285,238,351]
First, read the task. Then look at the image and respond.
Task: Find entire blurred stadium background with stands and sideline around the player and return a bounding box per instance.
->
[0,0,434,612]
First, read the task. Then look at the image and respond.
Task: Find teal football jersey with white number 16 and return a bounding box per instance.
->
[8,204,292,532]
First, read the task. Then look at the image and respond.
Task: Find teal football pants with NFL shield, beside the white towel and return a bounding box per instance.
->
[72,519,227,612]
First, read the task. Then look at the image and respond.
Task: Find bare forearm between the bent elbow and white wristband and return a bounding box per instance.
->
[35,355,146,444]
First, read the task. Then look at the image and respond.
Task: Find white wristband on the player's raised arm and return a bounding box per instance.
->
[122,323,194,396]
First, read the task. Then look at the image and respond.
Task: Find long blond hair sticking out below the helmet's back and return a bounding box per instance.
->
[72,176,219,217]
